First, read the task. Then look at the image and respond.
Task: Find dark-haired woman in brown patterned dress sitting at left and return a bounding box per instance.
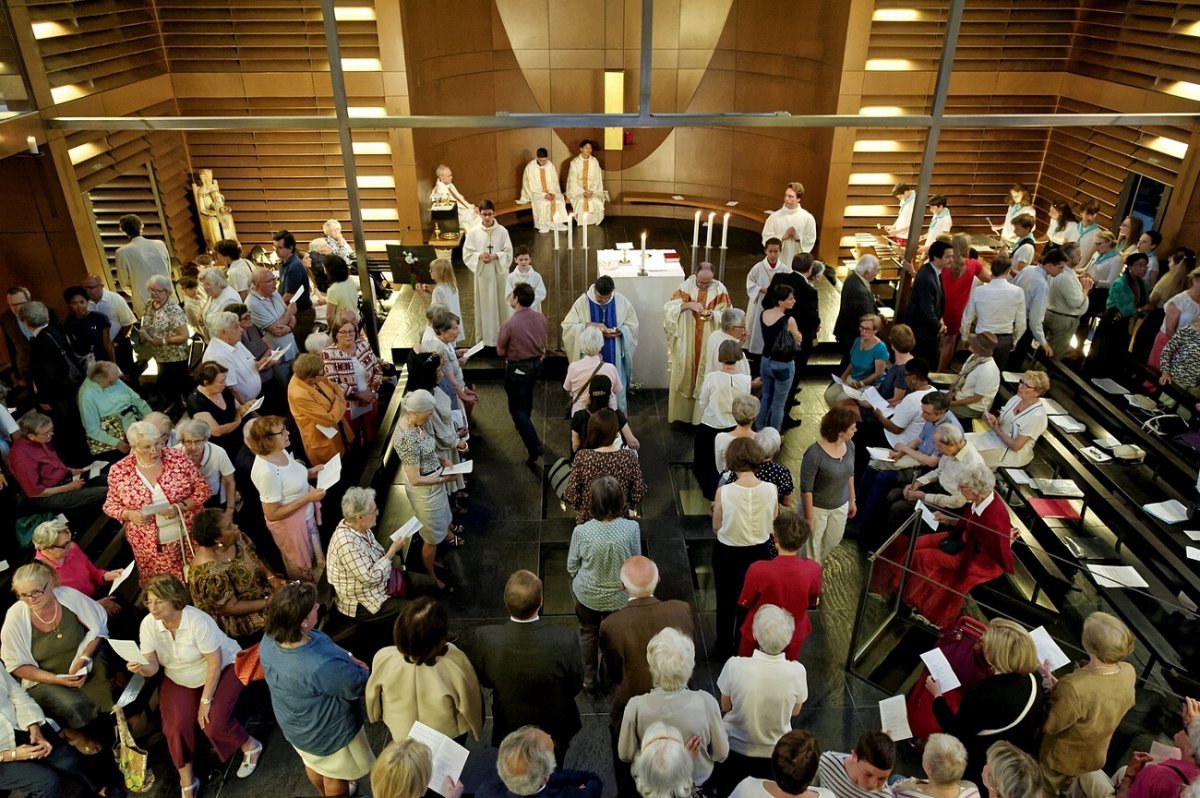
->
[187,508,286,644]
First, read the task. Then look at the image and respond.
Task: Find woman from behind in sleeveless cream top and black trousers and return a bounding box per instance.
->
[713,438,779,654]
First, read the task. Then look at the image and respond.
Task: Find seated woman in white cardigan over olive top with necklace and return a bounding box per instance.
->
[0,563,113,755]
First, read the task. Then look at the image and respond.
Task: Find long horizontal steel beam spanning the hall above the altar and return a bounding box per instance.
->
[47,112,1200,131]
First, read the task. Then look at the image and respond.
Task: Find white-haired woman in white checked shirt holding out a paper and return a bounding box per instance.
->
[325,487,432,618]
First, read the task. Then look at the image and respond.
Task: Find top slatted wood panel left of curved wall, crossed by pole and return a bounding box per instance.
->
[155,0,379,72]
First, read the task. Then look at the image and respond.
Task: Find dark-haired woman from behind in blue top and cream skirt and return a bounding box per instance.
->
[261,582,374,798]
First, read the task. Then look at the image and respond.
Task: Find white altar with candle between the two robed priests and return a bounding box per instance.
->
[596,248,684,388]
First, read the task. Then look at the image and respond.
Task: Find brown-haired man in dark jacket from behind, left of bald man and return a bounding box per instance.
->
[470,570,583,767]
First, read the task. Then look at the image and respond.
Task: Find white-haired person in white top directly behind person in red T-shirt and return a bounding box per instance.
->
[716,604,809,786]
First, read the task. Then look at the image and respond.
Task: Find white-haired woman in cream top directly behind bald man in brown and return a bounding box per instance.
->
[617,626,730,794]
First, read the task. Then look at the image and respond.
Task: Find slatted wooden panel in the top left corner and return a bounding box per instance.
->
[25,0,167,96]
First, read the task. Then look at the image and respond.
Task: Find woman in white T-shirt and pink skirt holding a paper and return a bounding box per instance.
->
[246,415,325,582]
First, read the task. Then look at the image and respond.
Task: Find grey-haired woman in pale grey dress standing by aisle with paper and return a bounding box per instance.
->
[391,391,464,590]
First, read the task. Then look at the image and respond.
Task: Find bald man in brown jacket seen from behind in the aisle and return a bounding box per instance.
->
[600,554,696,796]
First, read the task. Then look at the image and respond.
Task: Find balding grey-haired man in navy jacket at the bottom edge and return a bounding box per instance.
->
[475,726,604,798]
